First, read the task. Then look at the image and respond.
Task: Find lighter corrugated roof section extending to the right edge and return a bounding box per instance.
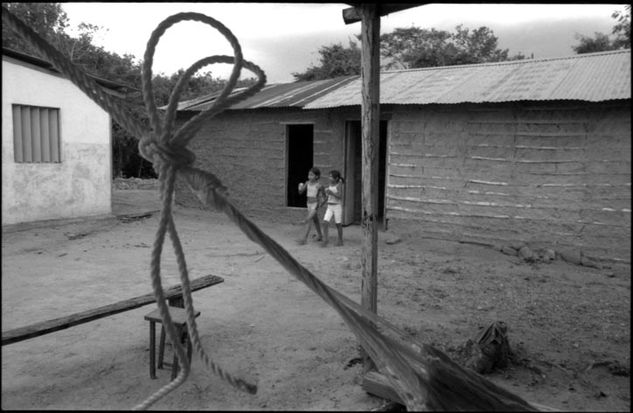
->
[304,50,631,109]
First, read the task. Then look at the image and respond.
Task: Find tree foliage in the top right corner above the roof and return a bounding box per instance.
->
[572,4,631,54]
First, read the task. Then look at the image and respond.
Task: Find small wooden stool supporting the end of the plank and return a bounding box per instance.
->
[145,307,200,380]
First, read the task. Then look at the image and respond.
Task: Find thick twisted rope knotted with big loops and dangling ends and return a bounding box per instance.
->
[2,7,266,409]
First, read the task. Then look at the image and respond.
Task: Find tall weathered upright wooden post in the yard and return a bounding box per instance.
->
[359,3,380,373]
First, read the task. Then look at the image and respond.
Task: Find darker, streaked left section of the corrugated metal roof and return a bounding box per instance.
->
[173,76,358,111]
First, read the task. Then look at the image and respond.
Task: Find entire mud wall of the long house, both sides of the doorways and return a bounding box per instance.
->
[176,101,631,264]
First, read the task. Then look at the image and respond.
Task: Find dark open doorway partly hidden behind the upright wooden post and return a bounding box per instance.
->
[343,120,387,225]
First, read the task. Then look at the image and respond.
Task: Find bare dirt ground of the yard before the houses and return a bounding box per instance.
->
[1,190,631,411]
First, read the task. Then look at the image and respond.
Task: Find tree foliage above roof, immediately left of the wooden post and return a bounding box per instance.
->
[292,40,360,80]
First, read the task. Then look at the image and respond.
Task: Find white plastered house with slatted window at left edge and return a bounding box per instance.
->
[2,48,130,226]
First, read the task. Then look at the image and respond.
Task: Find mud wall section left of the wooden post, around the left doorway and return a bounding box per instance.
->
[176,108,344,219]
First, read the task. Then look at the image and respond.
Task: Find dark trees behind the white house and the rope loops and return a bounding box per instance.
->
[2,3,255,178]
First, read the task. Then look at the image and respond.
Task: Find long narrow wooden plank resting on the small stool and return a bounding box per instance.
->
[2,275,224,346]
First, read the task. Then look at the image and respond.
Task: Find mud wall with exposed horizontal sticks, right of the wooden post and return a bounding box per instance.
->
[386,101,631,264]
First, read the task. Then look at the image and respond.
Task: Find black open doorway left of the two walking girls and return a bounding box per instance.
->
[286,125,314,208]
